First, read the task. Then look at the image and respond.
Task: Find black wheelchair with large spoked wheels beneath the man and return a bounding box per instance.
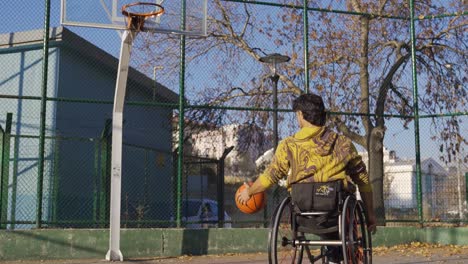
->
[268,184,372,264]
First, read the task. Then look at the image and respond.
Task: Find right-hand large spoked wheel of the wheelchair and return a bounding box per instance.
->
[341,196,372,264]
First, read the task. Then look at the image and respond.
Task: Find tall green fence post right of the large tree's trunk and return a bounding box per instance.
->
[410,0,424,225]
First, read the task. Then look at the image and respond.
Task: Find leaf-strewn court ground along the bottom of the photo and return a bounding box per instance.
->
[0,244,468,264]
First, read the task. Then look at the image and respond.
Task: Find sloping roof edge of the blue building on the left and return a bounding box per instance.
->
[0,27,179,103]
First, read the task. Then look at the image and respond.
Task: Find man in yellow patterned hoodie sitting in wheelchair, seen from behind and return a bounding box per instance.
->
[238,94,376,263]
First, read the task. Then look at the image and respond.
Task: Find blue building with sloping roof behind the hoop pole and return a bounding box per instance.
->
[0,27,178,228]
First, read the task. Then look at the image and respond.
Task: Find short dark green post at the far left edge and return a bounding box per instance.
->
[0,113,13,229]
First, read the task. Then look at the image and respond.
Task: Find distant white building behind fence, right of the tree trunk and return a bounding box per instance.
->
[359,149,466,219]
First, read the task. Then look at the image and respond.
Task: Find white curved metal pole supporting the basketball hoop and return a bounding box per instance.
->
[106,30,138,261]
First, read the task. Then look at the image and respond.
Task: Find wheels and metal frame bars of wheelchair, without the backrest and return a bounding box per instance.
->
[268,194,372,264]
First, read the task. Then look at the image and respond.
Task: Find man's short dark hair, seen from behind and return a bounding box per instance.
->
[293,93,326,126]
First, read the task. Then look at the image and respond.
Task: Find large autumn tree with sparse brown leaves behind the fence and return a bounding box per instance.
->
[139,0,467,222]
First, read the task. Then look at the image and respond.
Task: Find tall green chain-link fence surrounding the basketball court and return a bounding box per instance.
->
[0,0,468,229]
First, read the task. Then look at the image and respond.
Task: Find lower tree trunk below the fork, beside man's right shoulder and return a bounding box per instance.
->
[367,127,385,225]
